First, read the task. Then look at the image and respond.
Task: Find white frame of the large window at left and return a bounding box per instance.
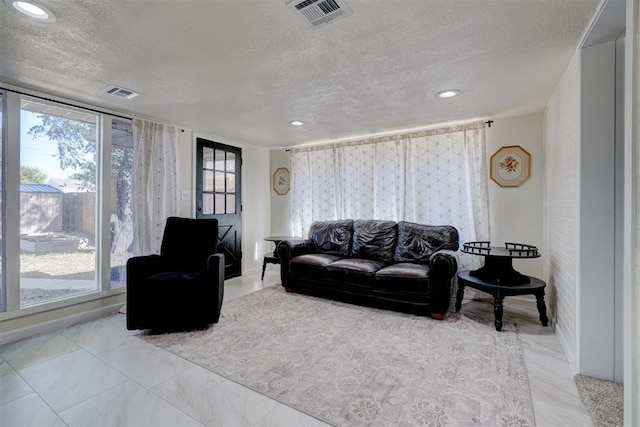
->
[0,88,132,321]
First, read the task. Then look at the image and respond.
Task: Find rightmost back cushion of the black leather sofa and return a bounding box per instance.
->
[393,221,458,262]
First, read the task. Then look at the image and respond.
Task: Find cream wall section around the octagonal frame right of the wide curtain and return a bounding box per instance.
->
[486,112,545,278]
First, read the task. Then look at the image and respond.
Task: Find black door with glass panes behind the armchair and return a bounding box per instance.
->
[196,138,242,279]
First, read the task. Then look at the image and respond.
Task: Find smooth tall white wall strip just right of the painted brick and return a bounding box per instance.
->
[576,41,622,379]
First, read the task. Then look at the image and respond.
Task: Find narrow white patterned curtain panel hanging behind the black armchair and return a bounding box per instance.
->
[133,119,178,255]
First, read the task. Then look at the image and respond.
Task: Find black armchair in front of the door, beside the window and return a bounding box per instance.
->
[127,217,224,330]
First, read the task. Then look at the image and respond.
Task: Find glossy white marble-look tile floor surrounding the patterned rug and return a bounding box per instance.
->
[0,266,592,427]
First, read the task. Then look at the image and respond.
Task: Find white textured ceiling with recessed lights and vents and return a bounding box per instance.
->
[0,0,598,146]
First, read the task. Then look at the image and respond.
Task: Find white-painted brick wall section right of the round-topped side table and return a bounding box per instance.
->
[544,57,580,367]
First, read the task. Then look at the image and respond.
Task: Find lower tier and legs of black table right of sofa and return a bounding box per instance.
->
[456,271,549,331]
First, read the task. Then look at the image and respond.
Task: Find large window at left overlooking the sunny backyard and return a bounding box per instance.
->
[0,91,133,311]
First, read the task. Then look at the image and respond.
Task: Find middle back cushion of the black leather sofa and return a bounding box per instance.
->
[351,219,398,261]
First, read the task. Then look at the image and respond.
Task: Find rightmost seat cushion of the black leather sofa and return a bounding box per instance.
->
[374,262,429,294]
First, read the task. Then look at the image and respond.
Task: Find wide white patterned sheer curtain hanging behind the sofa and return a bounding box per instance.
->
[291,123,489,265]
